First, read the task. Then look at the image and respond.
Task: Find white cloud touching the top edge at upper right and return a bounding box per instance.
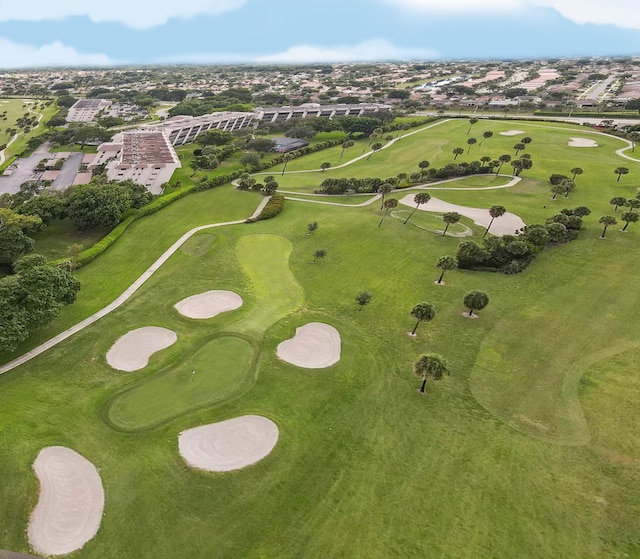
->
[381,0,640,29]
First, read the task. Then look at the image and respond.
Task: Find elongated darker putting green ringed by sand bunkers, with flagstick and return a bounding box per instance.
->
[107,335,257,431]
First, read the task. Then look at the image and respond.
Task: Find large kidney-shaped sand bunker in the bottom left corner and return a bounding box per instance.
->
[28,446,104,555]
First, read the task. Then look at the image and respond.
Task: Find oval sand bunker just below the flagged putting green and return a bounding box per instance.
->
[178,415,279,472]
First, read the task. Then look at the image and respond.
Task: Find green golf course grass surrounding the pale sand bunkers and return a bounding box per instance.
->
[0,116,640,559]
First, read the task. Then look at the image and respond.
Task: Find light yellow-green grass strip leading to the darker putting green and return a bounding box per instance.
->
[234,235,303,338]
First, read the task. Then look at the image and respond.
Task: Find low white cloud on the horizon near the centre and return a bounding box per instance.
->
[255,39,436,63]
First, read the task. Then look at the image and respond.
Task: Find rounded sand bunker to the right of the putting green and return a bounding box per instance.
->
[277,322,342,369]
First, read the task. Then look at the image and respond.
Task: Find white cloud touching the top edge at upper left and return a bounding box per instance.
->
[0,0,245,29]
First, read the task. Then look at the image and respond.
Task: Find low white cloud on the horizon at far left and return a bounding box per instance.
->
[0,38,116,68]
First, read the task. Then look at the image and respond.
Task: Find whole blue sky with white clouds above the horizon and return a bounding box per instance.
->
[0,0,640,68]
